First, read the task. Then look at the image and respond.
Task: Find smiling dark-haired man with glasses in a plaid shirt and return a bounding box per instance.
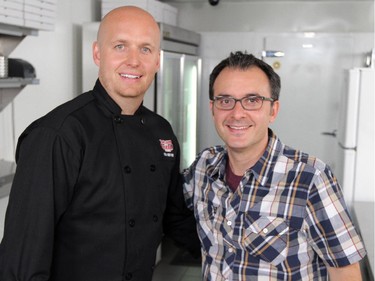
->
[184,52,366,281]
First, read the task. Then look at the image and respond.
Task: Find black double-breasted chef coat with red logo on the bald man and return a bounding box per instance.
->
[0,81,200,281]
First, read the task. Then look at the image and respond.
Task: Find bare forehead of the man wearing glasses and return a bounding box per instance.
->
[213,67,271,97]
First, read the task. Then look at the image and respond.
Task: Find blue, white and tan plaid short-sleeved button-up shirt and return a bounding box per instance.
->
[184,130,366,281]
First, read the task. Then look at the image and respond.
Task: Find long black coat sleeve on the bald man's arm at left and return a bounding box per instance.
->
[0,128,78,281]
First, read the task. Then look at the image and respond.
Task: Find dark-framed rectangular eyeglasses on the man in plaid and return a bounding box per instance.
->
[212,95,275,110]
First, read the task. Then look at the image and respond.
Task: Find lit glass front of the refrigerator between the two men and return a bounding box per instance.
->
[157,52,200,169]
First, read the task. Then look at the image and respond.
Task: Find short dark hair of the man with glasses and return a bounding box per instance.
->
[209,51,281,100]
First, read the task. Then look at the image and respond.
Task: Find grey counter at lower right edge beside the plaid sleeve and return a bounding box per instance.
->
[353,202,375,281]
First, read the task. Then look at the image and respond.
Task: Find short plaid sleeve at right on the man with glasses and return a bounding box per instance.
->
[305,167,366,267]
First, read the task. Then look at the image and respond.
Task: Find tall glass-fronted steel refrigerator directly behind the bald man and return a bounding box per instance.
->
[82,22,201,169]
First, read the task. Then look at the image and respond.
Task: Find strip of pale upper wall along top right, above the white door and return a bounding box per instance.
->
[171,0,374,32]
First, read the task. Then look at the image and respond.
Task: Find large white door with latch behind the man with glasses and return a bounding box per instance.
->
[264,33,353,169]
